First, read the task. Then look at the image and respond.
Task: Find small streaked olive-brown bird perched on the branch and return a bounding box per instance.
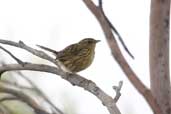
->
[37,38,100,72]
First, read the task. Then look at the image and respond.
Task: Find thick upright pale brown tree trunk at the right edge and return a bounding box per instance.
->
[150,0,171,114]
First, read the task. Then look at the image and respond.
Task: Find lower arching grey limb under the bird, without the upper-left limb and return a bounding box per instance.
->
[0,63,120,114]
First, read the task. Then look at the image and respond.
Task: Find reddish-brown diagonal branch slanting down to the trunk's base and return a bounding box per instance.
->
[83,0,162,114]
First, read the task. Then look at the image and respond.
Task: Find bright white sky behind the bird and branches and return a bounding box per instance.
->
[0,0,152,114]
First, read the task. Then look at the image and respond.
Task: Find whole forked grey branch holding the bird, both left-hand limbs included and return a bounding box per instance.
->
[0,39,120,114]
